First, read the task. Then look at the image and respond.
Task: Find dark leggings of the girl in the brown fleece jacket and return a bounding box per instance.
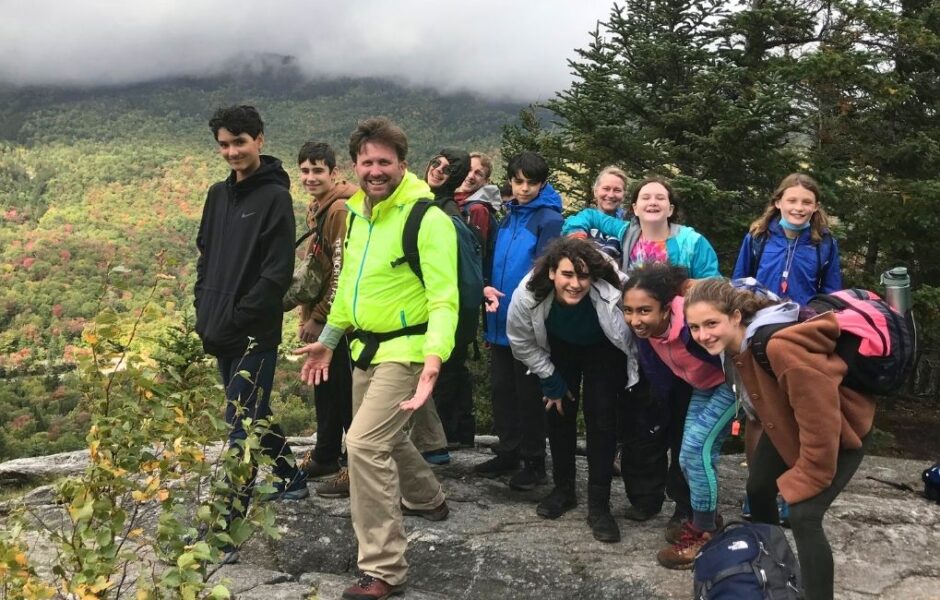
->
[747,434,870,600]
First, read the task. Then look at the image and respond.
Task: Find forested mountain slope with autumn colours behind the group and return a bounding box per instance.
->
[0,72,519,459]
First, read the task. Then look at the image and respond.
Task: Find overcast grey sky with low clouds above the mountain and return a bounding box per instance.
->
[0,0,613,100]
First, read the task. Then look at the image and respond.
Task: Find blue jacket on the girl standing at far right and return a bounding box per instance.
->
[731,220,842,305]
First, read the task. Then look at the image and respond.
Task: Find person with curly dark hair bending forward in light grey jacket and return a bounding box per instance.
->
[507,238,638,542]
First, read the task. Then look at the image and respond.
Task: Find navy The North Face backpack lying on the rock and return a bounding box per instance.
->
[692,522,803,600]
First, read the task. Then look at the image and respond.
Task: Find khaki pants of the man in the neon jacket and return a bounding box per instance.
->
[346,362,444,585]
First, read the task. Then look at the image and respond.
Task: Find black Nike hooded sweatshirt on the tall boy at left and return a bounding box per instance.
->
[193,156,295,358]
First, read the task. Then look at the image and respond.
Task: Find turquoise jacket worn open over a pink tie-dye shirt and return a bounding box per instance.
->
[562,208,721,279]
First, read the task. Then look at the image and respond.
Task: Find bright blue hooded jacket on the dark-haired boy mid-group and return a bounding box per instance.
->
[485,183,564,346]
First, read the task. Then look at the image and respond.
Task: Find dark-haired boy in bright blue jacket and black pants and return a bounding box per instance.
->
[475,152,564,490]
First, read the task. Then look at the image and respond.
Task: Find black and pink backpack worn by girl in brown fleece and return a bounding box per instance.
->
[750,289,915,396]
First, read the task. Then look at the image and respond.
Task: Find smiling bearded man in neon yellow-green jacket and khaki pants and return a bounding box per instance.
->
[296,117,458,600]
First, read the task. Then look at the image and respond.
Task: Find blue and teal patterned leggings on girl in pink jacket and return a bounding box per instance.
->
[679,383,736,529]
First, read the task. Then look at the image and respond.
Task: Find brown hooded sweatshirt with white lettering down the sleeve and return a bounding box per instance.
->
[300,180,359,323]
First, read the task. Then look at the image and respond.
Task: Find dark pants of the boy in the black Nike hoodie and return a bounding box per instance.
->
[217,350,297,510]
